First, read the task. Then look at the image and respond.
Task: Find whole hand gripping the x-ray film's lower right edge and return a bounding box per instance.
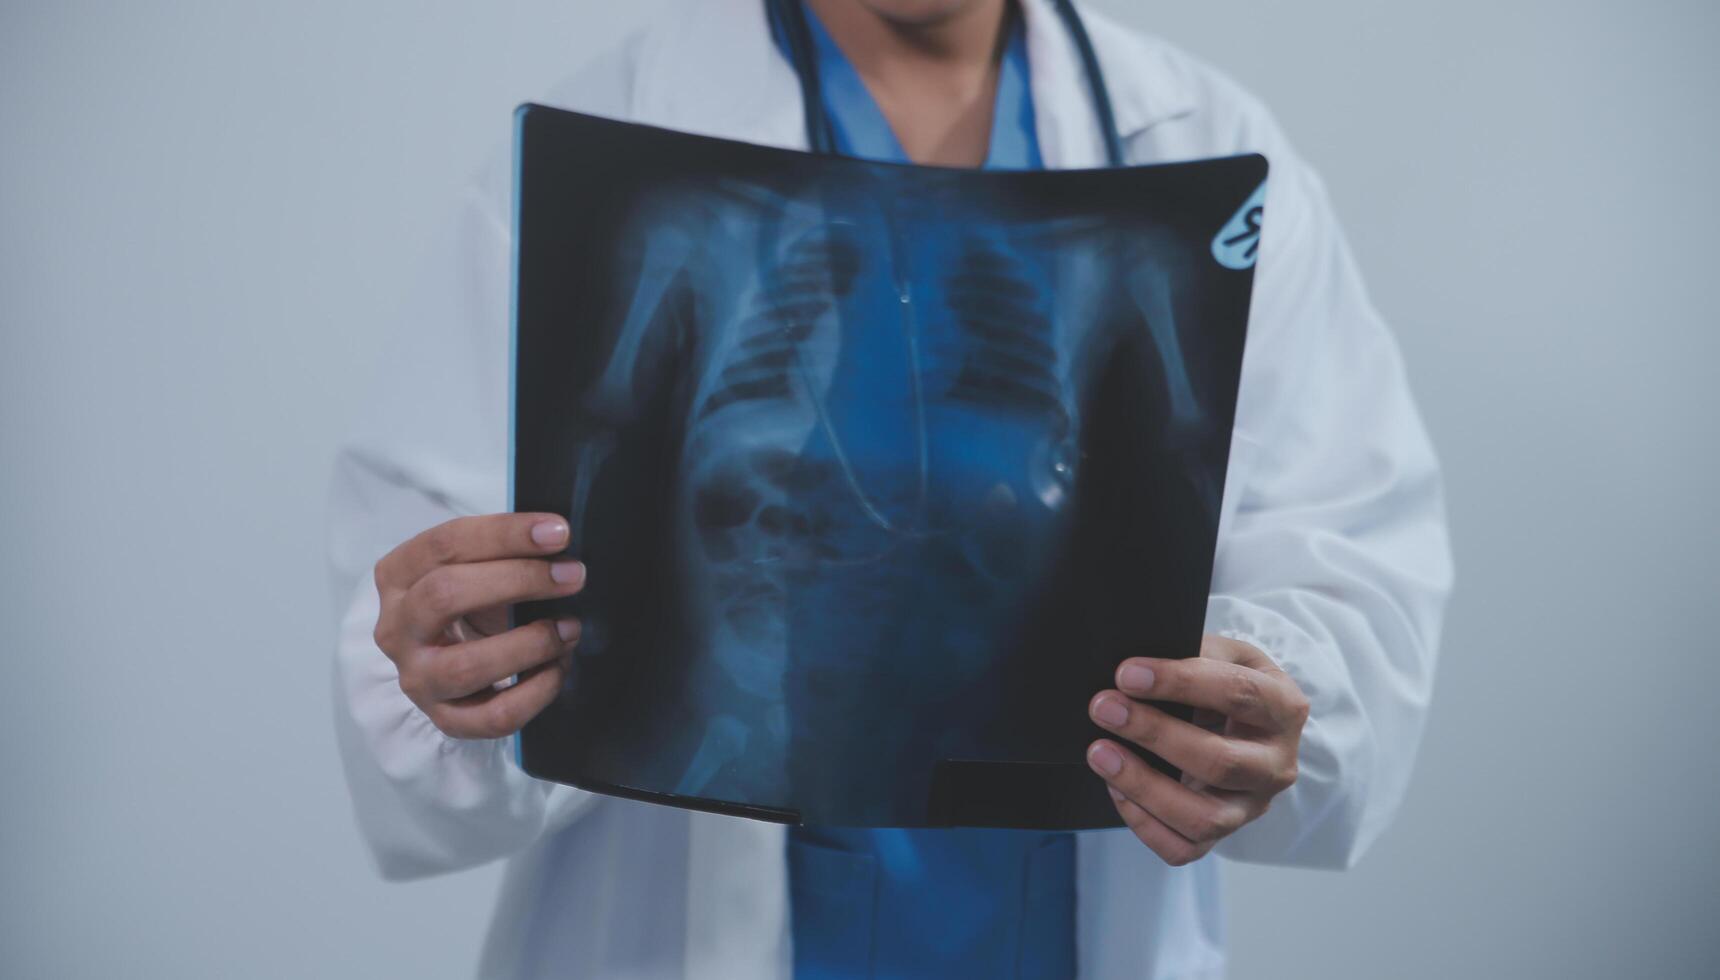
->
[1087,634,1307,865]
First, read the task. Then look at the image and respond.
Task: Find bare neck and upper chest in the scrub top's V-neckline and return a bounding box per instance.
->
[803,0,1011,167]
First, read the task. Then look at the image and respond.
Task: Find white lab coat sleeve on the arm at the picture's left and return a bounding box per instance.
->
[329,39,646,879]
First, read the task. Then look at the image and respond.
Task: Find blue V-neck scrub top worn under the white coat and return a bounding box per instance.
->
[777,3,1075,980]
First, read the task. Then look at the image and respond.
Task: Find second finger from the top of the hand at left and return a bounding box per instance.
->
[397,559,585,643]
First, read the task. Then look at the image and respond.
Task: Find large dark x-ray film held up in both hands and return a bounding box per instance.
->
[513,107,1266,829]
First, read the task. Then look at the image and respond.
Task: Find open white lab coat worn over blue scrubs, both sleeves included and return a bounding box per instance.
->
[330,0,1452,980]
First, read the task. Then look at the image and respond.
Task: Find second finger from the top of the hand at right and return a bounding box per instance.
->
[1087,691,1295,793]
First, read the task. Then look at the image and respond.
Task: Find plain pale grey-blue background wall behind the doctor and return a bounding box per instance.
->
[0,0,1720,978]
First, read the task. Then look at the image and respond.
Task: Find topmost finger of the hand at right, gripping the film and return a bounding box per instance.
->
[1116,657,1305,731]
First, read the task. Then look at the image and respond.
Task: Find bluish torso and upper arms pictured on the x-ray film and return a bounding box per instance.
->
[569,172,1218,822]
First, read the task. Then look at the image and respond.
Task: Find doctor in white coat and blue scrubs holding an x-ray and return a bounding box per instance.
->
[330,0,1452,978]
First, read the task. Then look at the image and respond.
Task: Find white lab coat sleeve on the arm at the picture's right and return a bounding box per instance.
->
[1207,99,1452,868]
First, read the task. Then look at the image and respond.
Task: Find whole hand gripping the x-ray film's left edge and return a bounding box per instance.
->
[375,514,585,739]
